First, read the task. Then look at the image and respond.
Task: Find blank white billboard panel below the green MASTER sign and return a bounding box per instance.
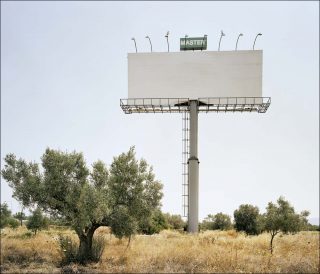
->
[128,50,262,99]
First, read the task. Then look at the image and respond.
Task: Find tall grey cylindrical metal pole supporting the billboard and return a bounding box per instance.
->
[188,100,199,233]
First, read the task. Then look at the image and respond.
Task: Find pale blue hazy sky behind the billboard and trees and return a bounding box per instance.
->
[1,1,319,224]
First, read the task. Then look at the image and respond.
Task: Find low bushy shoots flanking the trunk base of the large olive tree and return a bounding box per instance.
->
[59,235,105,265]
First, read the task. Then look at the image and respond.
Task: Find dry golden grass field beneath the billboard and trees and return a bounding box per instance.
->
[1,227,319,273]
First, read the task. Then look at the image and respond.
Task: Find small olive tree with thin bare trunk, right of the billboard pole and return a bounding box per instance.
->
[264,197,309,254]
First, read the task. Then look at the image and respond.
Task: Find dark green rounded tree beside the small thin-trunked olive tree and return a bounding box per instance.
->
[233,204,261,235]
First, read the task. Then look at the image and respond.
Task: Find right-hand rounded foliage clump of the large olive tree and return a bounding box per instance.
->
[108,148,163,238]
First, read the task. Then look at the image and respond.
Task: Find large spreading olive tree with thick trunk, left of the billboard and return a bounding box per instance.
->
[2,147,162,263]
